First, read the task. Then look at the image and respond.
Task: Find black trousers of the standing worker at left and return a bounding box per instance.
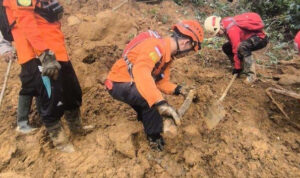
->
[20,59,82,127]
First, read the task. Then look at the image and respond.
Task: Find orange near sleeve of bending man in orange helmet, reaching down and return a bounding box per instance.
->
[132,47,164,107]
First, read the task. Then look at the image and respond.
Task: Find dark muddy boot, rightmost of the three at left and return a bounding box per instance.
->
[65,108,87,135]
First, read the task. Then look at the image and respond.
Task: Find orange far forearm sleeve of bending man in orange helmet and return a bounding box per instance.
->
[157,65,177,94]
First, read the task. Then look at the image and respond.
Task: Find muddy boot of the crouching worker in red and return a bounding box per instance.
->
[243,55,256,84]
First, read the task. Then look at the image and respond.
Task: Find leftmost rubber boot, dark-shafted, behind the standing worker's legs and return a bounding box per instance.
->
[16,95,36,134]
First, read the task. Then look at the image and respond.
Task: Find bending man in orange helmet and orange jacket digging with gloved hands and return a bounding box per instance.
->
[105,20,203,150]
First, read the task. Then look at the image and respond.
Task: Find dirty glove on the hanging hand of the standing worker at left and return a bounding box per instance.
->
[39,50,61,80]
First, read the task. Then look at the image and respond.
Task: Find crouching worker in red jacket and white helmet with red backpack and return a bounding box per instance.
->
[204,12,268,83]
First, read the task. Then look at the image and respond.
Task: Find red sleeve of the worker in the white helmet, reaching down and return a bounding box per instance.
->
[227,27,242,69]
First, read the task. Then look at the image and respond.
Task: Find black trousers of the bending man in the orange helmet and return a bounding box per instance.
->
[109,82,163,136]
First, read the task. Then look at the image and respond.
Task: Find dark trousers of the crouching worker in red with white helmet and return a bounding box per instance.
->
[222,35,269,62]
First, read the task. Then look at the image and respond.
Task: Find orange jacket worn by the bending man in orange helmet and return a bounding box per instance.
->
[107,38,177,107]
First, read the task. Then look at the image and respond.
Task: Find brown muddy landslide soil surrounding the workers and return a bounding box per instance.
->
[0,0,300,178]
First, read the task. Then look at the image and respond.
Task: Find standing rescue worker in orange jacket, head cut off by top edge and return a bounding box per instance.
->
[3,0,83,152]
